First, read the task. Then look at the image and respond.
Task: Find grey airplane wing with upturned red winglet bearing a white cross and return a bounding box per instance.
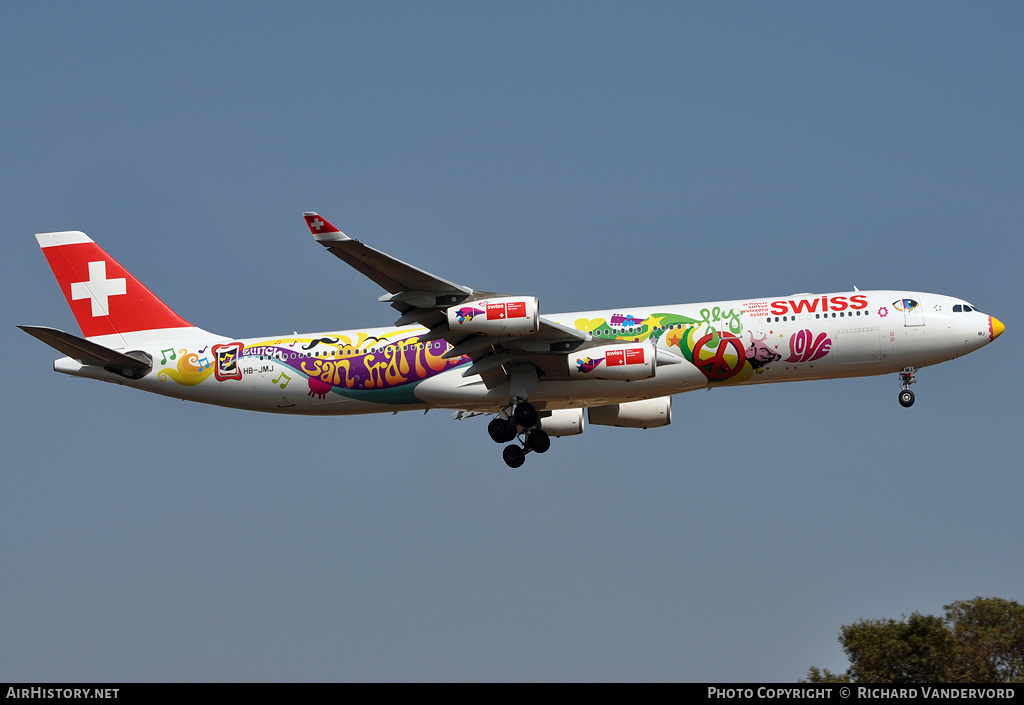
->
[302,212,591,388]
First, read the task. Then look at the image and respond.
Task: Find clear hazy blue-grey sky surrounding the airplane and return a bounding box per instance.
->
[0,2,1024,681]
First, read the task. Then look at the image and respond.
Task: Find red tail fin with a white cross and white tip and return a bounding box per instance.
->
[36,232,193,338]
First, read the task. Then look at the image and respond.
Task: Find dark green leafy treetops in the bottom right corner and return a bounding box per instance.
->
[807,597,1024,683]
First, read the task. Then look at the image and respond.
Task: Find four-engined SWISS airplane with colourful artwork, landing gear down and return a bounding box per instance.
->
[18,212,1005,467]
